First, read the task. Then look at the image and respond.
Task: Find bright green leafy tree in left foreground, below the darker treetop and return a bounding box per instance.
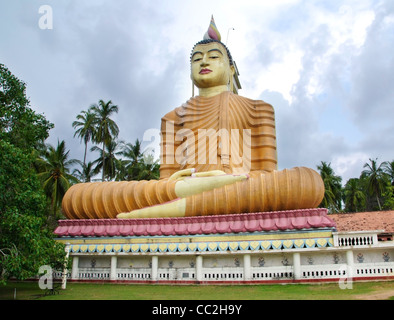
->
[0,140,64,282]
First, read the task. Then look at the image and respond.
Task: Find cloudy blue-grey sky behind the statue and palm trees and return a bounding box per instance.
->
[0,0,394,182]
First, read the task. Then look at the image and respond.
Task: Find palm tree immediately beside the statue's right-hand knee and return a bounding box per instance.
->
[317,161,342,213]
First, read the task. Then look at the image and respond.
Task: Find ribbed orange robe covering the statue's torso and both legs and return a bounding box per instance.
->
[63,92,324,219]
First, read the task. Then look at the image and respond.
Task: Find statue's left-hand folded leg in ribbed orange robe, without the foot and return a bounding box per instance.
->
[62,179,177,219]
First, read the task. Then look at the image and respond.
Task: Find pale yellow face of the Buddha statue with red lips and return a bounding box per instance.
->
[191,42,234,88]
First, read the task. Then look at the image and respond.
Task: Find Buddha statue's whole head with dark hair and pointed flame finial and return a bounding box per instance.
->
[190,17,234,89]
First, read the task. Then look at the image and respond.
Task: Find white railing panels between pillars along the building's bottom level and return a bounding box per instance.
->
[73,262,394,282]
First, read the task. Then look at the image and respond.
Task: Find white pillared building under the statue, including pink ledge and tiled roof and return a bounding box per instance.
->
[55,209,394,283]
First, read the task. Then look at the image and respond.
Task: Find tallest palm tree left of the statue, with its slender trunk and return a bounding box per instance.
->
[91,100,119,181]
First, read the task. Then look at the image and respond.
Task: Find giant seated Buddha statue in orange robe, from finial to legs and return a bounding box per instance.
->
[62,18,324,219]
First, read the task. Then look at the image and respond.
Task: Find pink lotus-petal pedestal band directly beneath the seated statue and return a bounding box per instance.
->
[55,208,336,237]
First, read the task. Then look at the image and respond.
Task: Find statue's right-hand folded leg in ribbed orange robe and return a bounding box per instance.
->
[185,167,324,216]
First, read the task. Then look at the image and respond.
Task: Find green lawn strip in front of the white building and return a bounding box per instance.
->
[0,281,394,300]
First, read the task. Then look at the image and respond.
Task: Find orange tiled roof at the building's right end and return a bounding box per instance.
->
[329,211,394,233]
